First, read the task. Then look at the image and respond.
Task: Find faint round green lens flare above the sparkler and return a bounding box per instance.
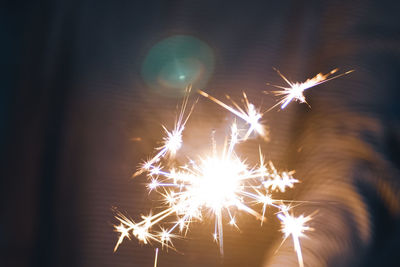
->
[142,35,214,97]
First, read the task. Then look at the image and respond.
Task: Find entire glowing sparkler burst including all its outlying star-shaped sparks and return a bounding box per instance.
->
[114,69,351,267]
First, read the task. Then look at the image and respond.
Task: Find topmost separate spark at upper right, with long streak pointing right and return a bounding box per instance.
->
[264,69,354,110]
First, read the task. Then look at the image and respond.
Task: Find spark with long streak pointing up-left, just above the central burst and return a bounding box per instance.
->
[198,90,268,141]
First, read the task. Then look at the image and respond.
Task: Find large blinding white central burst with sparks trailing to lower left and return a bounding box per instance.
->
[115,123,297,254]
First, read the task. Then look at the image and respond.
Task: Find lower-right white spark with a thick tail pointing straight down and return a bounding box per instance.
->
[277,210,313,267]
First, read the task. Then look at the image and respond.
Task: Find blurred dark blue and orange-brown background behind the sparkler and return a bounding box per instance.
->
[0,0,400,267]
